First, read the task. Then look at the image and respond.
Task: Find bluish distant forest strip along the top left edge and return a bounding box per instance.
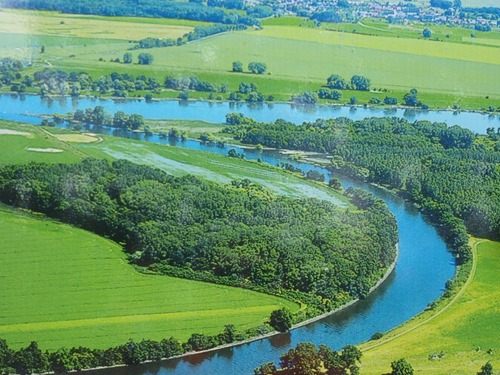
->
[3,0,260,26]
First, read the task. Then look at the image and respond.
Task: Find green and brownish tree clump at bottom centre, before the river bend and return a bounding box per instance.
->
[254,342,362,375]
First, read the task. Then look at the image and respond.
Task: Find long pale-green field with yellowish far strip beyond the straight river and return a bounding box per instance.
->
[23,22,500,99]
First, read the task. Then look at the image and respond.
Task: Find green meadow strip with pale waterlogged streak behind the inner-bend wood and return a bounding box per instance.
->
[0,121,348,206]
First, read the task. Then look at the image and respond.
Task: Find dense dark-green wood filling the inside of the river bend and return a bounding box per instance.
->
[0,159,397,314]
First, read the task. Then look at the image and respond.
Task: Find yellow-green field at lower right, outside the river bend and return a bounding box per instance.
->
[361,240,500,375]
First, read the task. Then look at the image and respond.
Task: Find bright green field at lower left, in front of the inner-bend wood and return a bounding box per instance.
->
[0,206,298,349]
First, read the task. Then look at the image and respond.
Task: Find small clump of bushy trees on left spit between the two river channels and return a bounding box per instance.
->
[49,105,144,130]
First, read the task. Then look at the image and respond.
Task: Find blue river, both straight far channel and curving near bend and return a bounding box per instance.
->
[0,95,470,375]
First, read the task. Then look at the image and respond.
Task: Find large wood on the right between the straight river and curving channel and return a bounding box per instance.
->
[225,118,500,263]
